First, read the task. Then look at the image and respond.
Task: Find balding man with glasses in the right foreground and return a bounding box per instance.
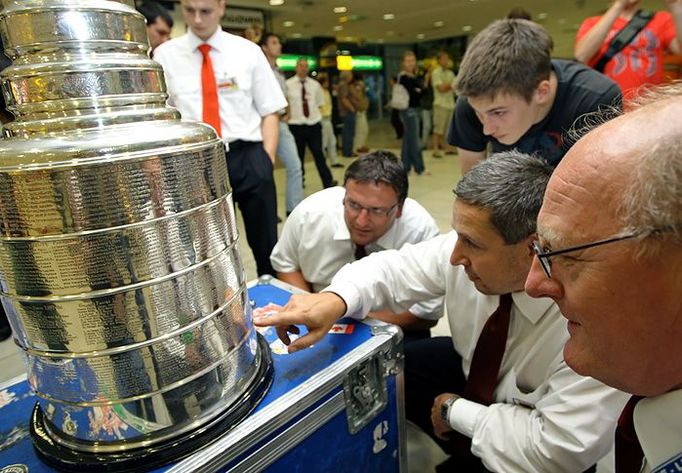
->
[526,83,682,473]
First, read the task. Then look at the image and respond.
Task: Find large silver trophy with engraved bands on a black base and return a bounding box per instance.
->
[0,0,272,471]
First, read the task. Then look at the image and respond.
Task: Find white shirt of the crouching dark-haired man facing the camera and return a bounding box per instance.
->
[270,187,443,320]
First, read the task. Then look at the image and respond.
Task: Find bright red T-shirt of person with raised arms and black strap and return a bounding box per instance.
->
[576,12,675,99]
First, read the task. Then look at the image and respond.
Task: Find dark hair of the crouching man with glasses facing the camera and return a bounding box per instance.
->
[343,150,409,205]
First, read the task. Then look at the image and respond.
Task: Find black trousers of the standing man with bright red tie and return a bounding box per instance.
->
[227,141,277,276]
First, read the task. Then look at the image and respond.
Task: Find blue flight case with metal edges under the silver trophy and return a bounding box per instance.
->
[0,277,407,473]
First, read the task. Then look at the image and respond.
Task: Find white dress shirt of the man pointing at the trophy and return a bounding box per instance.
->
[325,232,628,472]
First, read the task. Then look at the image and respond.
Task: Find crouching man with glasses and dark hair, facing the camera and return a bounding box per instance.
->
[270,151,442,341]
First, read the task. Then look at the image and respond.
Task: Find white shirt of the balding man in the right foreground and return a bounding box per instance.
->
[633,389,682,473]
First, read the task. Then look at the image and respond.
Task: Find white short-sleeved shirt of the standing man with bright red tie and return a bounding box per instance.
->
[154,28,287,142]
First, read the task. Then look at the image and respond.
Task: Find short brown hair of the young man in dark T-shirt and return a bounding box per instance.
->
[457,19,554,102]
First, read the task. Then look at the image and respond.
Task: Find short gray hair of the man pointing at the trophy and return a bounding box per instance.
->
[454,151,553,245]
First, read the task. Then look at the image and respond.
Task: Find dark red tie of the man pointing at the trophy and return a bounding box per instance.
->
[462,294,512,406]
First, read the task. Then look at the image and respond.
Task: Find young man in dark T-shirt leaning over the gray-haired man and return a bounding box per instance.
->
[449,19,621,173]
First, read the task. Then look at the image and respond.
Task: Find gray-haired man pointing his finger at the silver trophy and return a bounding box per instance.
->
[254,152,626,472]
